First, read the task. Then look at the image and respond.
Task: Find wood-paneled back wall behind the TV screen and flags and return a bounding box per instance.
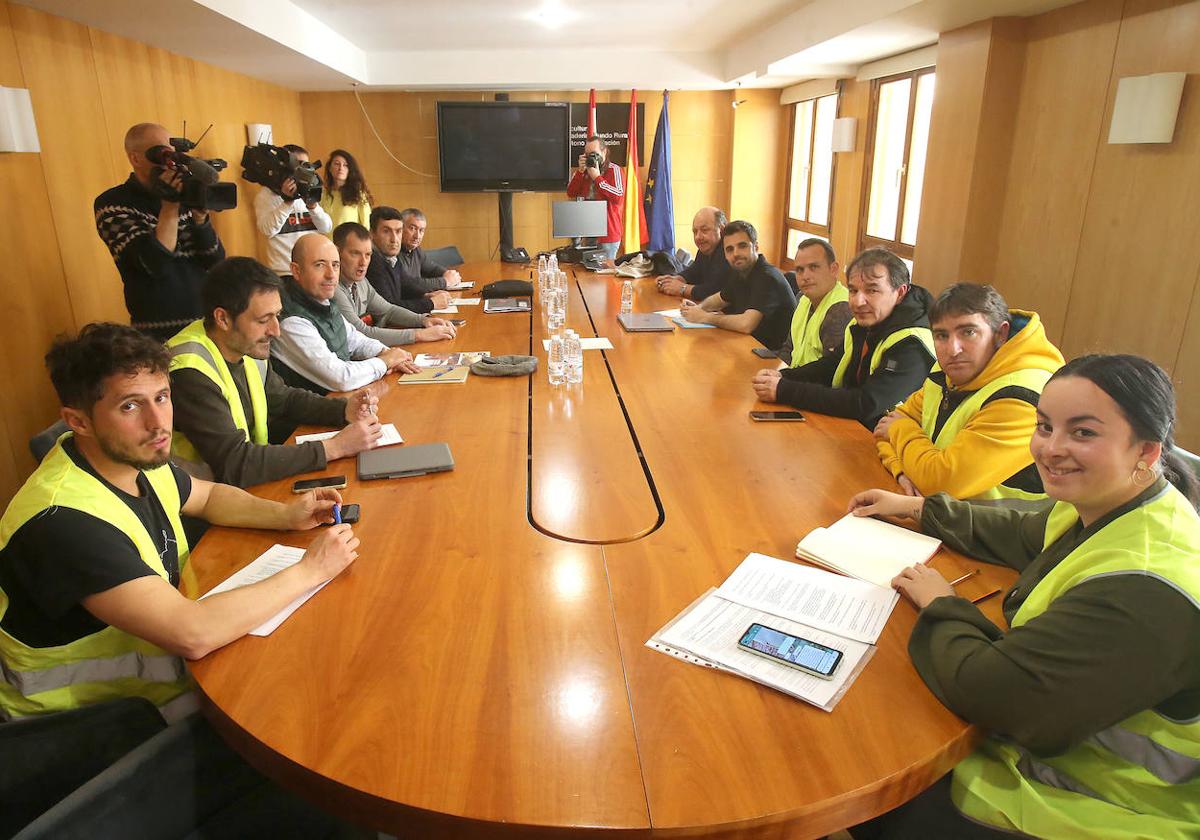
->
[300,90,763,260]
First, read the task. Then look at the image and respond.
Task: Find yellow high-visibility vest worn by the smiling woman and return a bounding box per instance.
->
[953,485,1200,840]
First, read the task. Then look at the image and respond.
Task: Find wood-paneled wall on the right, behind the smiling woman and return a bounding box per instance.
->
[914,0,1200,450]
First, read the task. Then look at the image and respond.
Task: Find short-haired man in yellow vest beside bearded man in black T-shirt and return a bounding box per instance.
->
[779,236,850,367]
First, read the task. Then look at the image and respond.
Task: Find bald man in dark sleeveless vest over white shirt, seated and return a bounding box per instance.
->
[271,233,418,395]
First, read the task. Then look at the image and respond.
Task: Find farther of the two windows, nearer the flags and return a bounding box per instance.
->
[782,94,838,264]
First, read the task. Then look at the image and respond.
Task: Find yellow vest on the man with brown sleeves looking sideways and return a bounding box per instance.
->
[167,320,268,462]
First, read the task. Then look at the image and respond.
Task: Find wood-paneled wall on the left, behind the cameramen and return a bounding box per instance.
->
[0,0,301,504]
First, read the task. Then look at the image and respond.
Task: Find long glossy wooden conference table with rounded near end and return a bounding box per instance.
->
[188,264,1012,838]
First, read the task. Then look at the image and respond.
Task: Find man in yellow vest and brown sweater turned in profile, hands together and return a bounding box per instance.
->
[167,257,382,487]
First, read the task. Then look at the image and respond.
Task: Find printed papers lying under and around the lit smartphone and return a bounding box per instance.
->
[646,554,899,712]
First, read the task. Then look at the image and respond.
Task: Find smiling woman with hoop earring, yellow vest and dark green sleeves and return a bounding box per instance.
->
[851,355,1200,840]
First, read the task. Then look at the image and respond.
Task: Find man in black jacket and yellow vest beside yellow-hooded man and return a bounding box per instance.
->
[751,248,934,428]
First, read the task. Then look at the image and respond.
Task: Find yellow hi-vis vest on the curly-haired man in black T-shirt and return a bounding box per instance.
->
[0,432,191,718]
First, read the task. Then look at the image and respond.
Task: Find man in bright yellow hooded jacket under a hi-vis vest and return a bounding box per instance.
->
[875,283,1063,504]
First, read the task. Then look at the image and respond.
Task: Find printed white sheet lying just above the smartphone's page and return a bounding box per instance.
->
[716,554,899,644]
